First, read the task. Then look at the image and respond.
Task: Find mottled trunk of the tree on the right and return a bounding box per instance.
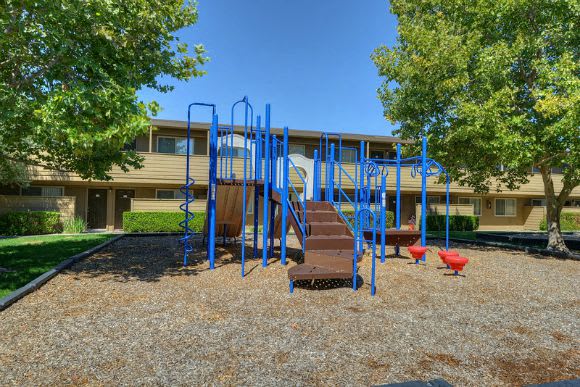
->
[540,166,570,254]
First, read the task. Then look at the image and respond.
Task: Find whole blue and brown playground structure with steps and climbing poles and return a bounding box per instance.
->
[180,97,460,295]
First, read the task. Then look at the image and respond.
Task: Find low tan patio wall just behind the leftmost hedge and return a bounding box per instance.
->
[0,195,75,219]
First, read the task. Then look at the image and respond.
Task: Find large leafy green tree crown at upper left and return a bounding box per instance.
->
[0,0,207,184]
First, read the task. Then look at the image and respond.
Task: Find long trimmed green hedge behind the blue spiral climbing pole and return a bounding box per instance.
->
[123,211,205,232]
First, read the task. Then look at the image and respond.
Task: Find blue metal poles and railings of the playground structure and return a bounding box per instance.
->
[180,97,449,295]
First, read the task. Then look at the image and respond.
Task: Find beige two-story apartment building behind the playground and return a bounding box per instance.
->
[0,119,580,230]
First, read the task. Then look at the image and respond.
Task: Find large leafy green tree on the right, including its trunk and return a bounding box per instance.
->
[372,0,580,252]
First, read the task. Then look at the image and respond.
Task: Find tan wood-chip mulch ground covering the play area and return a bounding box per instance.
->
[0,237,580,386]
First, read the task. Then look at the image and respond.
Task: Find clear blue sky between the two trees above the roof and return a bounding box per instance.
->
[139,0,396,135]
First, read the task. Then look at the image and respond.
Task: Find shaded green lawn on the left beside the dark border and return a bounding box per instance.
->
[0,234,113,298]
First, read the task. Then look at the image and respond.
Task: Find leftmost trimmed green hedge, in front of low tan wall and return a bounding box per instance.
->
[0,211,62,235]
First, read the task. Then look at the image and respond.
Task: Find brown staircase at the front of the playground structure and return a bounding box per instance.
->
[288,202,361,281]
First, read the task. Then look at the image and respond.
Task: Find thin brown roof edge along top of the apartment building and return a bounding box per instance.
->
[151,118,412,144]
